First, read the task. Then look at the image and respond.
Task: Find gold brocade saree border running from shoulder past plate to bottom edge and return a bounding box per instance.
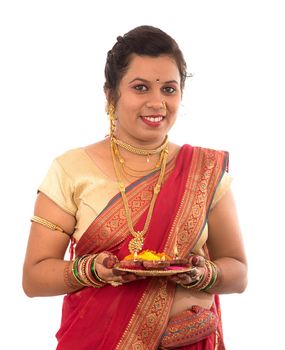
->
[116,147,228,350]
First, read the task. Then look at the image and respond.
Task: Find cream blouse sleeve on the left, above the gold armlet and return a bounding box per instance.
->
[38,159,77,216]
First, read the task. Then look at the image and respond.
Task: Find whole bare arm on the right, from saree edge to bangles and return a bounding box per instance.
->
[207,190,247,294]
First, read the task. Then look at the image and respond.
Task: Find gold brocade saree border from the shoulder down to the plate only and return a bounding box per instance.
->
[165,147,228,257]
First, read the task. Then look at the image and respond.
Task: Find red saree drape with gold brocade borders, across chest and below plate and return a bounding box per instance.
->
[57,145,227,350]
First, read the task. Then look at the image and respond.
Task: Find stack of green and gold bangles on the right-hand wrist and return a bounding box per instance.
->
[180,260,218,292]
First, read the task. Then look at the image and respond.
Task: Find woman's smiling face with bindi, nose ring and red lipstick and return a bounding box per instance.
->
[112,55,181,145]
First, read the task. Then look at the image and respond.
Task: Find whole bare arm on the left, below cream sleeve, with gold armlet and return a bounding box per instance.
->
[23,193,82,297]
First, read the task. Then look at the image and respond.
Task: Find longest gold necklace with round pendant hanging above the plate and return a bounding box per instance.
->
[111,138,168,254]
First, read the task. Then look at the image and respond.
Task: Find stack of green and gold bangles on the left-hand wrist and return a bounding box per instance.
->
[72,254,107,288]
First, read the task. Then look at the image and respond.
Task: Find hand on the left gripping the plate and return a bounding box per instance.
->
[95,252,145,286]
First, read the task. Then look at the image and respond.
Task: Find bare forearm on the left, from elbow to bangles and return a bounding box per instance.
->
[23,259,83,297]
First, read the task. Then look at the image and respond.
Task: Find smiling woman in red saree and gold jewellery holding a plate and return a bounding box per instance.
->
[23,26,247,350]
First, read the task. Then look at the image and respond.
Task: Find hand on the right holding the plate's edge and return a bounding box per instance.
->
[169,255,205,285]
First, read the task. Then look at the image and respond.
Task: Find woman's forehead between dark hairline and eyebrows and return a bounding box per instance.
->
[122,55,180,83]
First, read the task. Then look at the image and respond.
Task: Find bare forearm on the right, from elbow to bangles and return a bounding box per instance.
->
[207,258,247,294]
